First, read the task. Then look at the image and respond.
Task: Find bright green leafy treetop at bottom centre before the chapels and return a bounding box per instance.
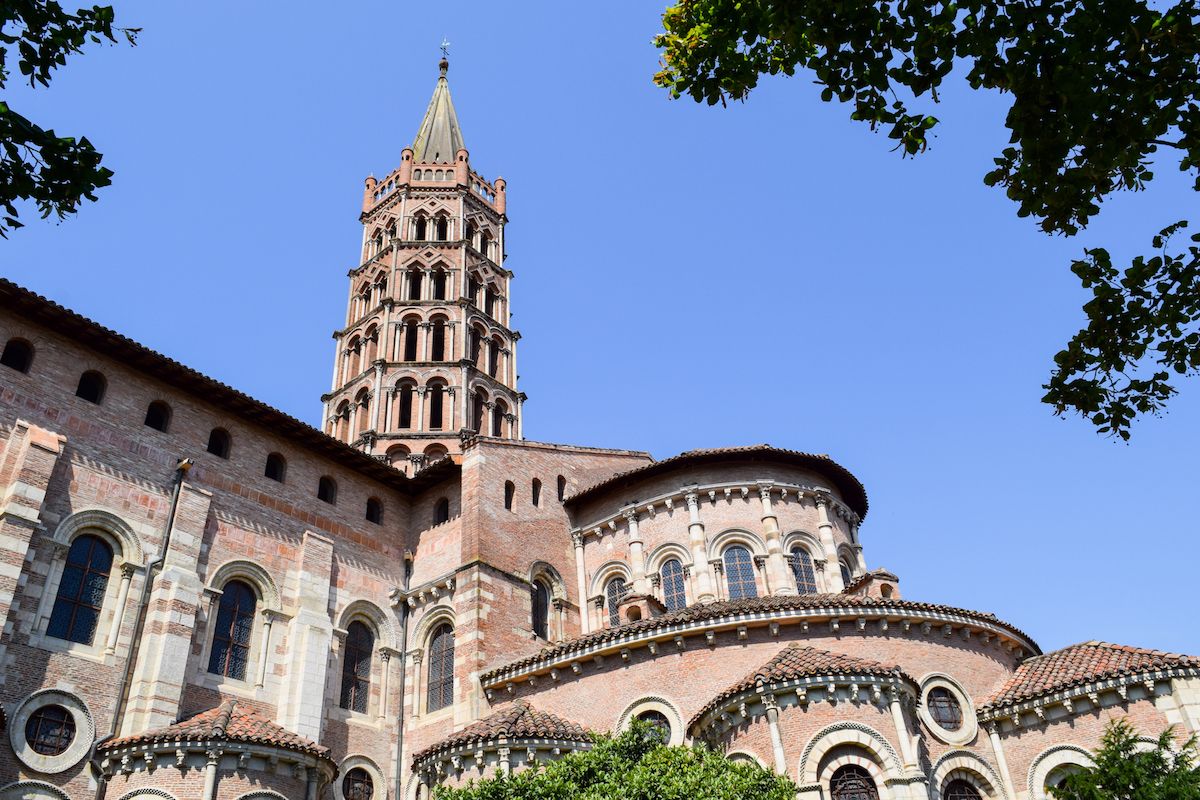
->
[434,722,797,800]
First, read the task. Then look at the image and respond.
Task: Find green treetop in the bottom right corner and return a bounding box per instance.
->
[1050,720,1200,800]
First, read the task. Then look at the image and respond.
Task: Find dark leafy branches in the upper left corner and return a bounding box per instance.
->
[0,0,139,237]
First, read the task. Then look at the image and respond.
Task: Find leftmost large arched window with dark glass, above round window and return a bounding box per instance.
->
[46,534,112,644]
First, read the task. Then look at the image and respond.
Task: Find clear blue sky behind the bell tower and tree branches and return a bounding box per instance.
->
[0,0,1200,652]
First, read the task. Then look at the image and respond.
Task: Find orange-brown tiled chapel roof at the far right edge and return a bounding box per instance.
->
[980,642,1200,711]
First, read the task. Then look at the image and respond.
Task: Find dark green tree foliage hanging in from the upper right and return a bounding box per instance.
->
[654,0,1200,438]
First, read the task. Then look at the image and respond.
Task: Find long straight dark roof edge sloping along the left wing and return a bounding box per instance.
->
[0,278,458,492]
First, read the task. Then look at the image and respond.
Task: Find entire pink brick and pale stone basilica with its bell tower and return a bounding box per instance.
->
[0,60,1200,800]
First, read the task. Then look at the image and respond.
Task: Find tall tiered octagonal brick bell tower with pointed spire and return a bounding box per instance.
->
[322,58,524,471]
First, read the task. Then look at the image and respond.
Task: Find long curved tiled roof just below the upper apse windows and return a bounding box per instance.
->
[480,595,1037,686]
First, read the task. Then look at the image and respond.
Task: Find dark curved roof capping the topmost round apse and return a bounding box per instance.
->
[565,444,866,517]
